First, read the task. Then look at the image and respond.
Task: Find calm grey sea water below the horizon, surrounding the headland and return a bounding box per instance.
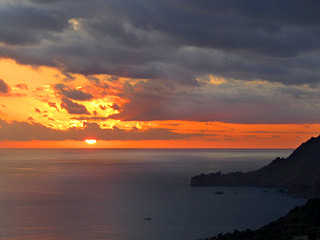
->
[0,149,306,240]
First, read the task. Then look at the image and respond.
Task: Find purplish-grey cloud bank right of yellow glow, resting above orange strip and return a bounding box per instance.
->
[109,81,320,124]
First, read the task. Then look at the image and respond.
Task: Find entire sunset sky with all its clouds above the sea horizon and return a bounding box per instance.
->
[0,0,320,148]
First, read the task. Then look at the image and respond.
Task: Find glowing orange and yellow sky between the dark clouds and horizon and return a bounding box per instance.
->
[0,59,320,148]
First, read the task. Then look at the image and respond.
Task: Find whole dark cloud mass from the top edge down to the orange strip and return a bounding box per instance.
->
[0,0,320,123]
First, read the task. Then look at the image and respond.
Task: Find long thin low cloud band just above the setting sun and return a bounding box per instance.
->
[0,119,202,141]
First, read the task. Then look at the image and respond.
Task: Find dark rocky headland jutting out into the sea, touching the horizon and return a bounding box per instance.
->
[191,136,320,198]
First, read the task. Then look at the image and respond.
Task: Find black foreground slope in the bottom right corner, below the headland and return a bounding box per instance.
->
[204,198,320,240]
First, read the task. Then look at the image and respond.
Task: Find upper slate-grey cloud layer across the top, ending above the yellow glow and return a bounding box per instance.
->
[0,0,320,85]
